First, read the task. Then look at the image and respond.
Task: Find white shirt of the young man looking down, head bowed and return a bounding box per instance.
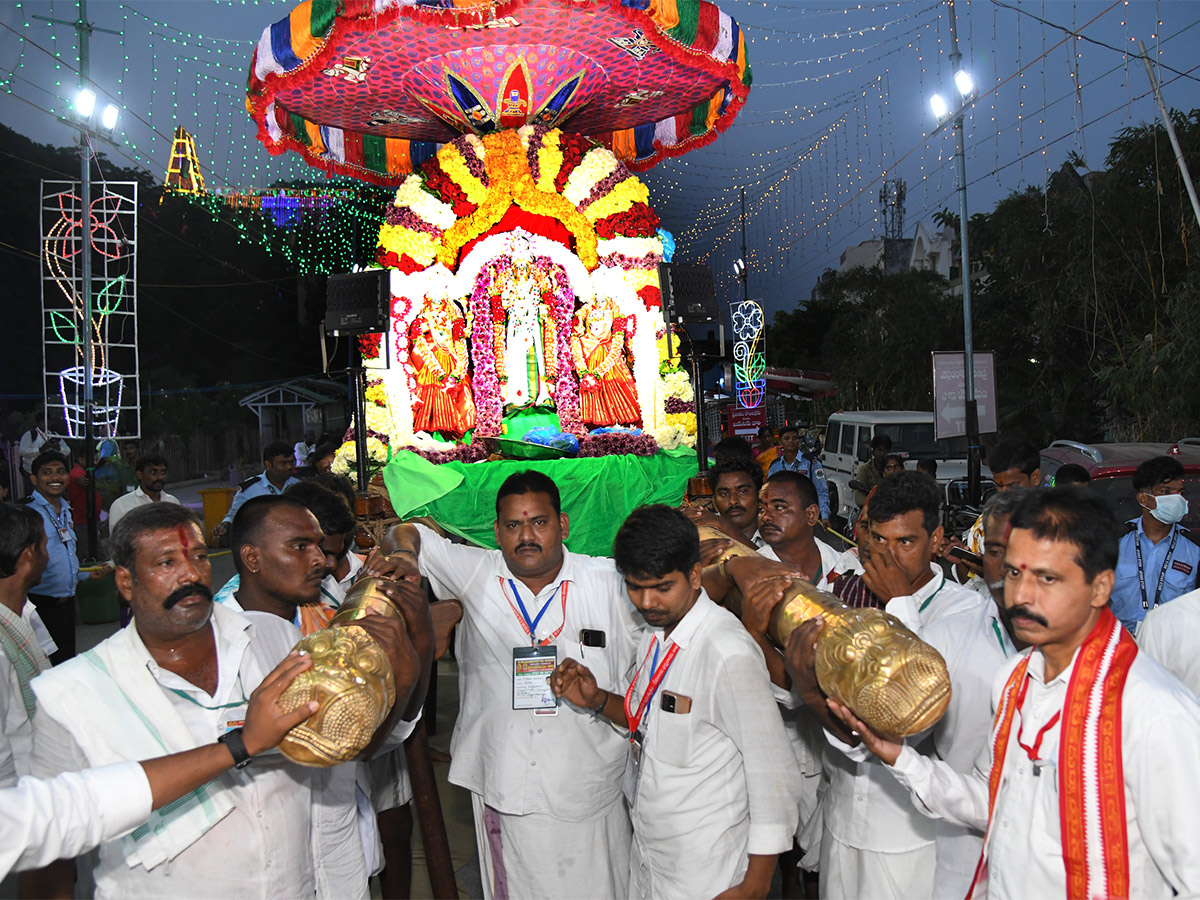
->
[626,592,799,900]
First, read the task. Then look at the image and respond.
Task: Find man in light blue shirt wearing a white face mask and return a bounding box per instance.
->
[1112,456,1200,634]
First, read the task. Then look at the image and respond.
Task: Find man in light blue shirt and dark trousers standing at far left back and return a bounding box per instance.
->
[29,451,108,665]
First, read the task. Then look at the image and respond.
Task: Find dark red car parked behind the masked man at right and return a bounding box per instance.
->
[1042,438,1200,530]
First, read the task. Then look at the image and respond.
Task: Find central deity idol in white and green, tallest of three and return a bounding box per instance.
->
[496,238,558,408]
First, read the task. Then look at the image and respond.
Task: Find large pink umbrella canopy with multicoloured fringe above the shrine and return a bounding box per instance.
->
[247,0,750,185]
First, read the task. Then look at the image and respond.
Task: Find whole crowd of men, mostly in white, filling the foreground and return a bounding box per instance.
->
[0,430,1200,899]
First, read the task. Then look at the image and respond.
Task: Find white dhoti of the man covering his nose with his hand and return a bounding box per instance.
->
[821,829,937,900]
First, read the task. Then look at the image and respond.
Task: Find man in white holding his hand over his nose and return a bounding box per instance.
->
[792,472,979,900]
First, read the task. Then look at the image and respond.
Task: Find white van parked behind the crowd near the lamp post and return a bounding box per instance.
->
[821,409,989,518]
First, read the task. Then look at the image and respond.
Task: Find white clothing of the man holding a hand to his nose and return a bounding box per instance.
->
[821,563,979,900]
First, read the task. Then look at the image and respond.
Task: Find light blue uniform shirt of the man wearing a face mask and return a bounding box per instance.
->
[1111,517,1200,632]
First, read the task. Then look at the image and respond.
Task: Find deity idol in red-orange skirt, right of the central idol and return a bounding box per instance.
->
[571,299,641,425]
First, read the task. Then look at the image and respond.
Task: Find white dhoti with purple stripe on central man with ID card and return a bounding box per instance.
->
[470,793,632,900]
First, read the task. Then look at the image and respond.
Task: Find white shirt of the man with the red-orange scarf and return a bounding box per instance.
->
[889,650,1200,900]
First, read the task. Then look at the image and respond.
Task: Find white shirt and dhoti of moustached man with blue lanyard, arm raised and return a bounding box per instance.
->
[416,524,641,896]
